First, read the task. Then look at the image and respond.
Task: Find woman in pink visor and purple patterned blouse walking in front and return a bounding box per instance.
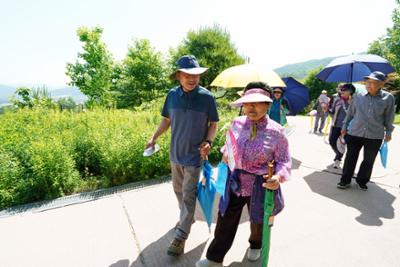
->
[196,83,291,267]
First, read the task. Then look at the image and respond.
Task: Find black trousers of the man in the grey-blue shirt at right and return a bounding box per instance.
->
[340,135,382,185]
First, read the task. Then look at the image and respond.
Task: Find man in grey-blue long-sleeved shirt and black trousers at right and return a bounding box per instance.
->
[337,71,395,191]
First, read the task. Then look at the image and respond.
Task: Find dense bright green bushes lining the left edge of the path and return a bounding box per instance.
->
[0,98,238,209]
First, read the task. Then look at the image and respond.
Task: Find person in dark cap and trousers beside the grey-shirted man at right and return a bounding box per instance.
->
[329,83,356,169]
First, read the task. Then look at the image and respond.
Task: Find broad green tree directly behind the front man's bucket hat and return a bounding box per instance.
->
[170,25,245,87]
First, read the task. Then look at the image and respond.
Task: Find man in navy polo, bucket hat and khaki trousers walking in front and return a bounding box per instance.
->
[146,55,219,256]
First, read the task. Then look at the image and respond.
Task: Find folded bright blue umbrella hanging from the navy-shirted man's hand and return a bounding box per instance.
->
[197,160,216,230]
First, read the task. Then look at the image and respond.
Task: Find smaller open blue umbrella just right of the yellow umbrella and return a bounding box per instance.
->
[282,77,310,115]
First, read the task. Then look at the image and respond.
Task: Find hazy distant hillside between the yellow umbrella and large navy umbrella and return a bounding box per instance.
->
[275,57,336,80]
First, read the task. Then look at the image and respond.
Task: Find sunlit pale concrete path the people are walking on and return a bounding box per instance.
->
[0,117,400,267]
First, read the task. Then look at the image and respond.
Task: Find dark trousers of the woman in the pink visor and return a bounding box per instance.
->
[206,194,263,262]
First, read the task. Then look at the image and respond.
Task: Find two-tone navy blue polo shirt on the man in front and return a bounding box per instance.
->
[161,86,219,166]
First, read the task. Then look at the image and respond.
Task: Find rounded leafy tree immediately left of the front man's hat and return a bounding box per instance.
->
[114,39,169,108]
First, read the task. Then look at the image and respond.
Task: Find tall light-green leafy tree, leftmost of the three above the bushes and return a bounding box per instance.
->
[66,27,114,107]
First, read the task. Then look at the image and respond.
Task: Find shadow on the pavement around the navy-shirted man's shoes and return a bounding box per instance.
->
[109,229,207,267]
